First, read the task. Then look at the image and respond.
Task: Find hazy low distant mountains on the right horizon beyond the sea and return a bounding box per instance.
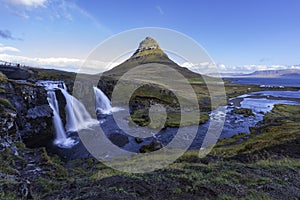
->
[217,69,300,78]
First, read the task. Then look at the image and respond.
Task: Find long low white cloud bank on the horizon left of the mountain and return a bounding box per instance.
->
[0,54,120,74]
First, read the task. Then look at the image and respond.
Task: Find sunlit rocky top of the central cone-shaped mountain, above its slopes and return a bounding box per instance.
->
[131,37,167,58]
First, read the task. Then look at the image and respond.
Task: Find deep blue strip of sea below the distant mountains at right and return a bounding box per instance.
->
[224,77,300,87]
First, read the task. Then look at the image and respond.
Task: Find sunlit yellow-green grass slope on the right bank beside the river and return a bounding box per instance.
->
[211,104,300,157]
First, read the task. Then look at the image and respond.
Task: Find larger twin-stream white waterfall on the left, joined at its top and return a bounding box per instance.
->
[37,81,98,148]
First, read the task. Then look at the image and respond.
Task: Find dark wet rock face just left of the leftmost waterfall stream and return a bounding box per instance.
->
[6,81,54,147]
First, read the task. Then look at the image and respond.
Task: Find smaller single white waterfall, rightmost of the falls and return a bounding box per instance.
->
[93,87,112,115]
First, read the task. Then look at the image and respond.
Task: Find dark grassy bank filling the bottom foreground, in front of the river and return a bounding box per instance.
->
[0,105,300,199]
